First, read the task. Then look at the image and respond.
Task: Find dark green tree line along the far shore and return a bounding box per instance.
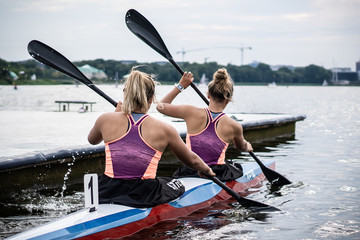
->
[0,58,331,85]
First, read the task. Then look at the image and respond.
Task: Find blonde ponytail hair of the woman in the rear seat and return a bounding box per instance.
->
[122,67,156,114]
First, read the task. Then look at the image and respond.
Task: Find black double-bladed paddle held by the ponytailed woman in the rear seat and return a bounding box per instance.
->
[28,40,279,211]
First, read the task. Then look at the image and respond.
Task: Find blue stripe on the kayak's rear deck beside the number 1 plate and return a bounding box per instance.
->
[31,208,151,239]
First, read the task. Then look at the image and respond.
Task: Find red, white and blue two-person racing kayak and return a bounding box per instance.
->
[9,160,275,239]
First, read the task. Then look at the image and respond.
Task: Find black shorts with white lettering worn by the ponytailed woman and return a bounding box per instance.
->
[99,175,185,208]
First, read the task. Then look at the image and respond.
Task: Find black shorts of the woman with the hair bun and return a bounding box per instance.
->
[173,162,243,182]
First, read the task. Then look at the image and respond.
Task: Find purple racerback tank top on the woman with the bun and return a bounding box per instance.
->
[186,108,229,165]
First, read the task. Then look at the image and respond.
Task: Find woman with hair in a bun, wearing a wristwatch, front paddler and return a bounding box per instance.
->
[157,68,253,181]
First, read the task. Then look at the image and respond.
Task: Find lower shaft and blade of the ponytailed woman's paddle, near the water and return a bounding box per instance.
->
[205,174,281,211]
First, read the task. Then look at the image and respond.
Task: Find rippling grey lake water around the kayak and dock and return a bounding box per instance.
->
[0,86,360,240]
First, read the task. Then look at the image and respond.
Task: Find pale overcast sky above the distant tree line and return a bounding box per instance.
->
[0,0,360,71]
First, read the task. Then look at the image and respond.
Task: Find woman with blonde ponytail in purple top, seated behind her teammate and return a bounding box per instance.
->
[88,66,215,208]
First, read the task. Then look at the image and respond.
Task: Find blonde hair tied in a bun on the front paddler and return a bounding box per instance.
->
[208,68,234,102]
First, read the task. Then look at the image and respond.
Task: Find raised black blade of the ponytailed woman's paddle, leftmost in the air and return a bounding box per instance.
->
[28,40,93,85]
